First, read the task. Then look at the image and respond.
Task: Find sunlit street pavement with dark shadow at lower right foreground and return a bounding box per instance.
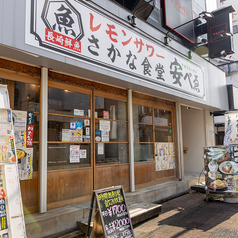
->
[134,193,238,238]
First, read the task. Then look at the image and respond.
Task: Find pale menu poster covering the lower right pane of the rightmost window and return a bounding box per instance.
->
[155,143,175,171]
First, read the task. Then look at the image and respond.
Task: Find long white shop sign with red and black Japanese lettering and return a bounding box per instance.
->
[25,0,205,99]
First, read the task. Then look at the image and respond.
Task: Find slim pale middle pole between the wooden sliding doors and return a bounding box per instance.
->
[128,89,135,192]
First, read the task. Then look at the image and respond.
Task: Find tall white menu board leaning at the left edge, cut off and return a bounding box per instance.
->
[0,108,26,238]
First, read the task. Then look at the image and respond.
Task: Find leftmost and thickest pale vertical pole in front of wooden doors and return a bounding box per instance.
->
[39,67,48,213]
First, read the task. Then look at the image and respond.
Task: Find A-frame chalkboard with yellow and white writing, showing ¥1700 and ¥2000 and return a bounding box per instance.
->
[86,186,135,238]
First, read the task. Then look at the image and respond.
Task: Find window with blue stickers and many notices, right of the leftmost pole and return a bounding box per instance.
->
[48,87,91,170]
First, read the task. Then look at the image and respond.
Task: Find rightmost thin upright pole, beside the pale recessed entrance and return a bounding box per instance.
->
[176,102,184,181]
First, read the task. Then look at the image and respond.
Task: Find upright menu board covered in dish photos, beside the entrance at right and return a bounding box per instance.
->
[204,145,238,196]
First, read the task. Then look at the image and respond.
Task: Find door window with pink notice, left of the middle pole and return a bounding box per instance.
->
[95,96,128,165]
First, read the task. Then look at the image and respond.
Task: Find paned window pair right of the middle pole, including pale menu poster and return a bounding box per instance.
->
[133,104,175,171]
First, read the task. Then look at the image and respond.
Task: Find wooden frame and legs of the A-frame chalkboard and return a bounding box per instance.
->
[86,185,135,238]
